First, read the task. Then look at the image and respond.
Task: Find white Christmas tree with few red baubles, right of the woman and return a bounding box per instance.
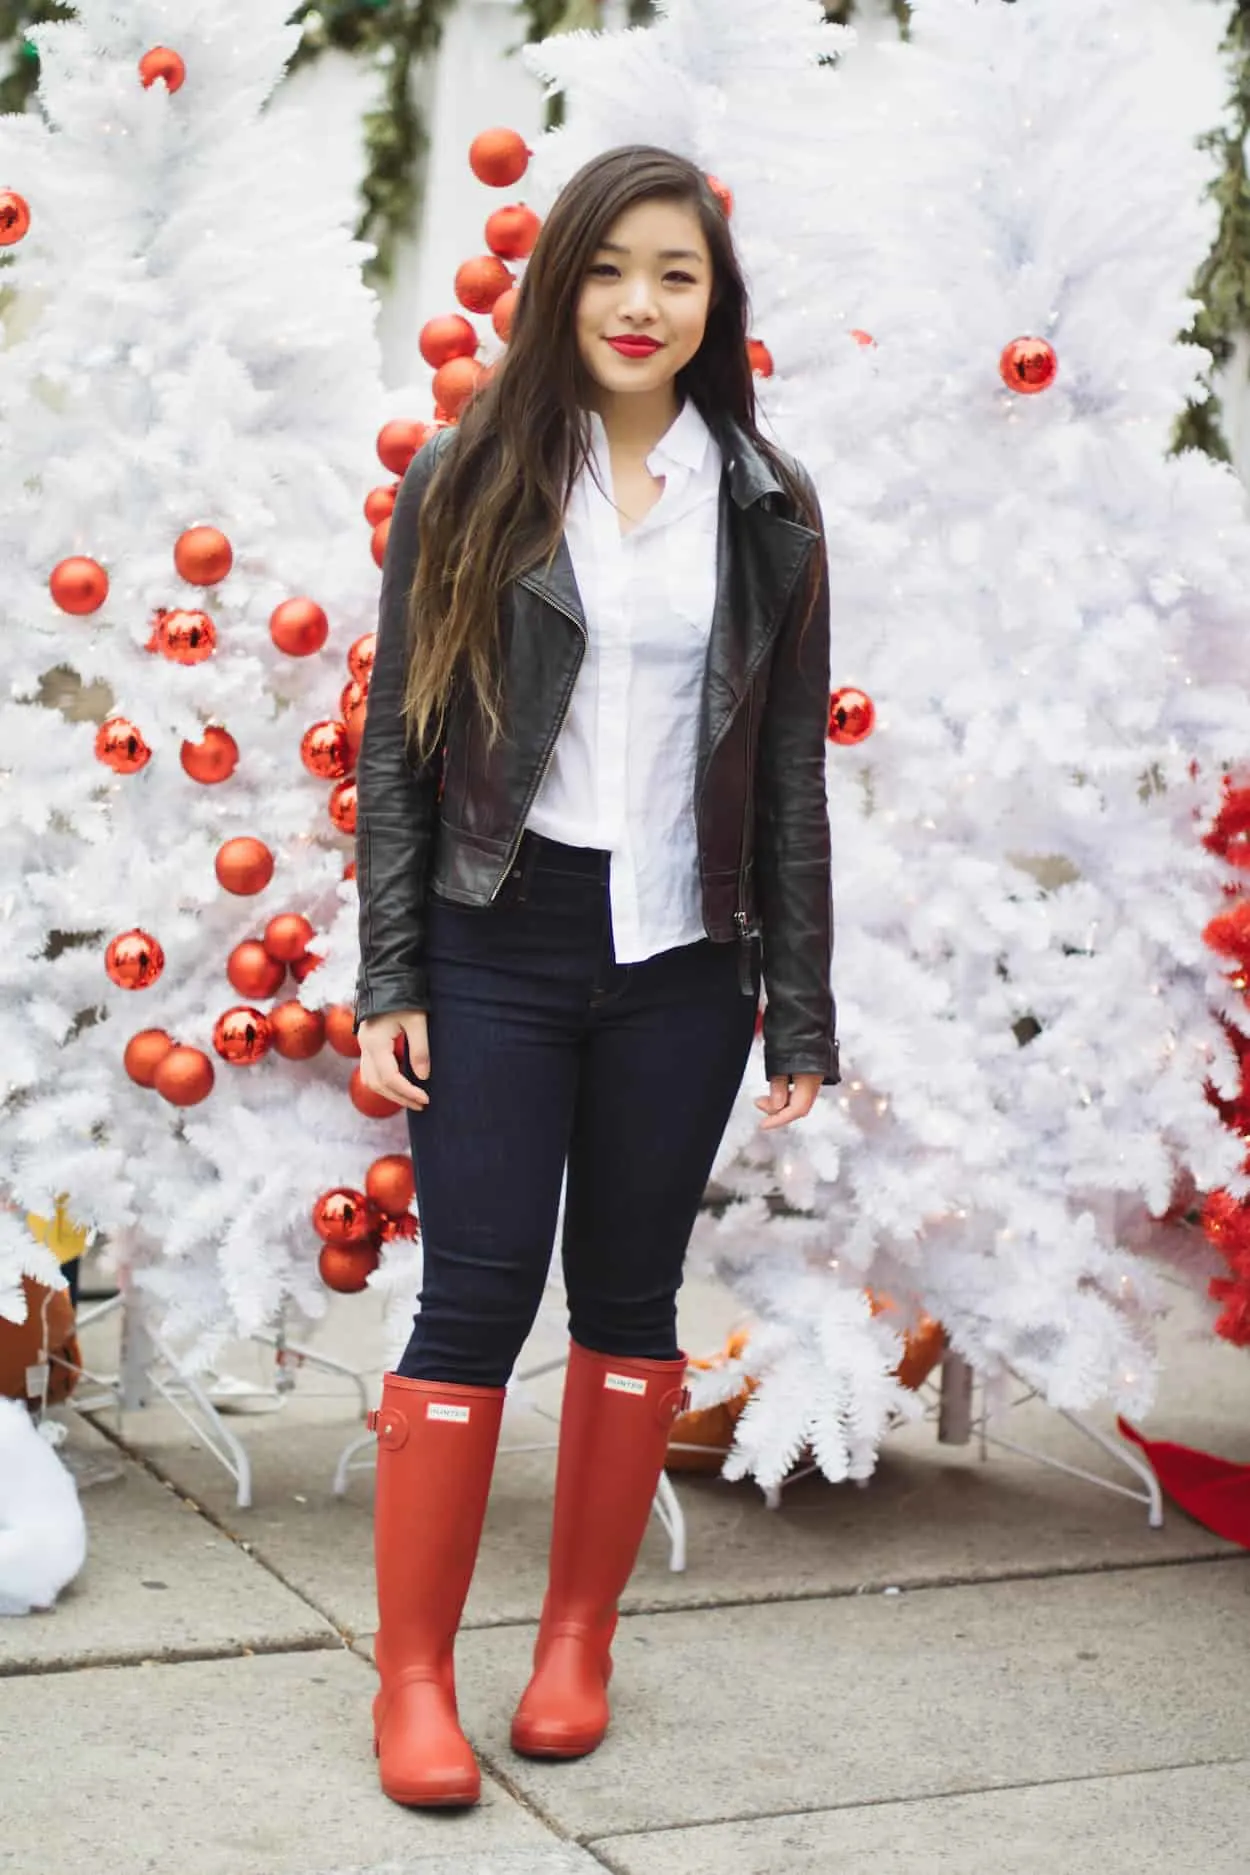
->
[530,0,1250,1485]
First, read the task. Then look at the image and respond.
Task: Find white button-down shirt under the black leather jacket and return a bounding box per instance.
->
[525,398,722,964]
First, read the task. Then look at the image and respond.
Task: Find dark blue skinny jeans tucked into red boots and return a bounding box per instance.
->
[397,831,759,1388]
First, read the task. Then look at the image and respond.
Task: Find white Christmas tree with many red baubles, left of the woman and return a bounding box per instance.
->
[0,0,423,1367]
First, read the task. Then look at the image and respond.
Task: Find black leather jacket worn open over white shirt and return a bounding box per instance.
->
[356,424,840,1086]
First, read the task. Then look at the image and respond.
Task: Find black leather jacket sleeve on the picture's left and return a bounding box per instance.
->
[354,431,442,1029]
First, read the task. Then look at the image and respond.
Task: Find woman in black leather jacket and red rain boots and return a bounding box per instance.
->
[356,146,838,1804]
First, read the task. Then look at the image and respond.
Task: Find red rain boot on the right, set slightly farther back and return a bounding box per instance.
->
[512,1341,690,1757]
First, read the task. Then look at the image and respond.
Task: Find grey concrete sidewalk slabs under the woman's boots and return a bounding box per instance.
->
[0,1283,1250,1875]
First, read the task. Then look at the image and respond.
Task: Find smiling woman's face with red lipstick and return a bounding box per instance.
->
[577,201,712,396]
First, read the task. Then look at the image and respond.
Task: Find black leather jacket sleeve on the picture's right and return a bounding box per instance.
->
[755,471,841,1088]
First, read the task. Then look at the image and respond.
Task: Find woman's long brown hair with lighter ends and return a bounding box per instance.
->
[403,144,815,761]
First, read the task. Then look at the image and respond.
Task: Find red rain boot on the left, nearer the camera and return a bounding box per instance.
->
[369,1374,504,1808]
